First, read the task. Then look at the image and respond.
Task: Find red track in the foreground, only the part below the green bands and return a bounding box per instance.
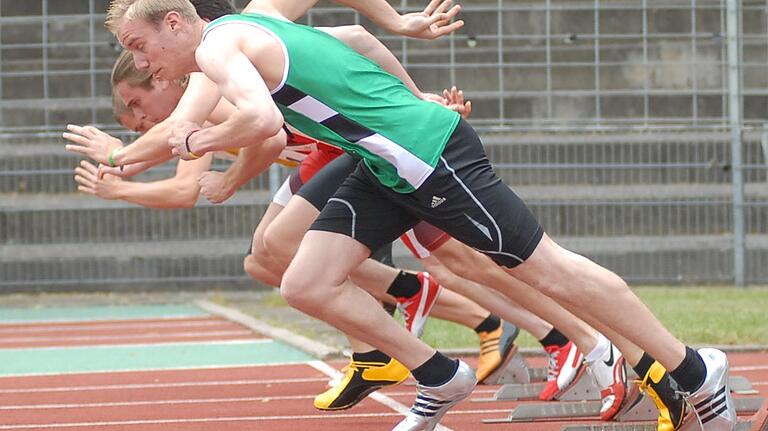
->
[0,354,768,431]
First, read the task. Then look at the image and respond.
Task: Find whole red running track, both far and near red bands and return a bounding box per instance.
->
[0,318,768,431]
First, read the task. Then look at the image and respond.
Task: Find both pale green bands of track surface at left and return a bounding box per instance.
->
[0,304,314,376]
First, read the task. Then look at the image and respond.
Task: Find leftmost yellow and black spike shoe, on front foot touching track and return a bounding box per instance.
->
[314,359,411,410]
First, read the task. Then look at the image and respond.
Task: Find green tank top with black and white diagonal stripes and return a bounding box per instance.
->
[203,14,459,193]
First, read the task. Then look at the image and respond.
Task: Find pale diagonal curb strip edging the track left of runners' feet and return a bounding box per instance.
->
[195,299,342,359]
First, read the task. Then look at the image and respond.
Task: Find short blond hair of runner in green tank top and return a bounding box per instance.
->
[104,0,200,34]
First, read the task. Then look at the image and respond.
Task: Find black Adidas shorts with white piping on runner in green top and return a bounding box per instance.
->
[310,120,544,267]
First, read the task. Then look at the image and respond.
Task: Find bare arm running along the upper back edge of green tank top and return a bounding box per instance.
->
[320,25,423,98]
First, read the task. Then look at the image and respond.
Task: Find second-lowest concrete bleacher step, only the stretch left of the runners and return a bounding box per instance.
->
[0,191,270,245]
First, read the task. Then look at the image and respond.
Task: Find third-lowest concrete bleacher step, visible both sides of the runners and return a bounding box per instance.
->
[0,132,768,191]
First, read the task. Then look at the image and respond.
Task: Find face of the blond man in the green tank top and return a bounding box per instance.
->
[117,12,196,80]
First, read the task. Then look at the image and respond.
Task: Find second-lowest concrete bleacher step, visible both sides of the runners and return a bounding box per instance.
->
[0,184,768,249]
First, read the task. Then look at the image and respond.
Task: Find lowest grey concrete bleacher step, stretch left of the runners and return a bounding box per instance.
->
[0,237,253,292]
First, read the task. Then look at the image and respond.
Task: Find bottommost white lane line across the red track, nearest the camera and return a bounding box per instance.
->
[0,409,509,430]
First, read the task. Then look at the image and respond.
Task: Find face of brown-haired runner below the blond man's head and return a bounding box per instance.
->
[115,79,184,123]
